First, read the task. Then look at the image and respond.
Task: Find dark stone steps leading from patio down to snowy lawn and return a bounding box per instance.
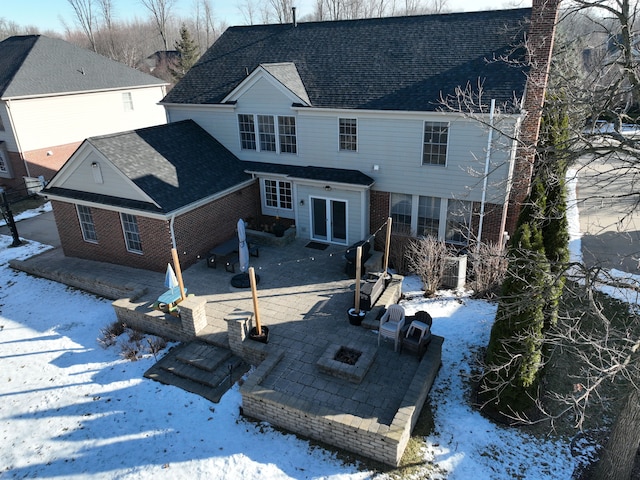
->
[144,341,250,403]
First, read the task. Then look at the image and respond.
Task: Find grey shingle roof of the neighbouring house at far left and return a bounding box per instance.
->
[0,35,166,99]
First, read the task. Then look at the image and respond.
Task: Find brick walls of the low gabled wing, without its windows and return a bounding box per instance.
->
[52,183,259,272]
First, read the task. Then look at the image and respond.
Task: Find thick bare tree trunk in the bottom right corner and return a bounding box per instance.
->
[593,385,640,480]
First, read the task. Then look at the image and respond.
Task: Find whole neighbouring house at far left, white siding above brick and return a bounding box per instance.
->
[0,35,167,189]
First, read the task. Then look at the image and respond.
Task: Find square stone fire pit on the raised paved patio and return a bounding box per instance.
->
[316,344,377,383]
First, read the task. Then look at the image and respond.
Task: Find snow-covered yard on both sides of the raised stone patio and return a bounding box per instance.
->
[0,193,596,480]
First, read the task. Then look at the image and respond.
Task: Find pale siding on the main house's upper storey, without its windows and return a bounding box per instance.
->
[168,91,514,204]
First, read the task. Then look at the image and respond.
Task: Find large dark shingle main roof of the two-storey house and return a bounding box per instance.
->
[164,9,531,111]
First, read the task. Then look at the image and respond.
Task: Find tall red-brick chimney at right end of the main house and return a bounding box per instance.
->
[502,0,560,234]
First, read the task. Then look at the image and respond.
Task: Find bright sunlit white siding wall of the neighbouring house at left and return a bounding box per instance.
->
[3,87,166,152]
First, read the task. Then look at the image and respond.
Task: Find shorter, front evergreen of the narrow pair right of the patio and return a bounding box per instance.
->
[480,178,551,416]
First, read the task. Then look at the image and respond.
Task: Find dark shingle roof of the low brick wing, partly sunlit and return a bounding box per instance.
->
[45,120,251,213]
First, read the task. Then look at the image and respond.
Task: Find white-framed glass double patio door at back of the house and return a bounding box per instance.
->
[311,197,347,245]
